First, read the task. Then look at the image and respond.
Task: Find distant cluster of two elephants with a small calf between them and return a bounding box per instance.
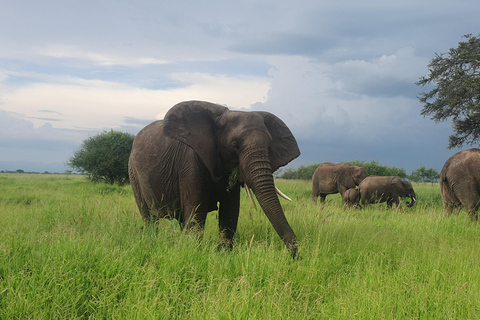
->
[312,162,417,208]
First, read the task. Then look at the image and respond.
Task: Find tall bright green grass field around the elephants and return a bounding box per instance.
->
[0,174,480,319]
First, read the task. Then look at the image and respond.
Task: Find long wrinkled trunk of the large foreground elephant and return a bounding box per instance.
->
[240,149,298,258]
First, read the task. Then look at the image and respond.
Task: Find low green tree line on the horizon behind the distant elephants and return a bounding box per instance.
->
[277,160,440,182]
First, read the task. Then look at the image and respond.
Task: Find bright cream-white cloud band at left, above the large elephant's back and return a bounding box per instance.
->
[0,73,269,130]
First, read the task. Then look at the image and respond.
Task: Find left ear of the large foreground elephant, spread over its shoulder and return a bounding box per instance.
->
[163,101,228,180]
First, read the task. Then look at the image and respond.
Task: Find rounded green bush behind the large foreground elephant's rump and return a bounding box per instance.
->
[68,130,135,185]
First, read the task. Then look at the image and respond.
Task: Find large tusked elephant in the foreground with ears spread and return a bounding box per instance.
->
[129,101,300,257]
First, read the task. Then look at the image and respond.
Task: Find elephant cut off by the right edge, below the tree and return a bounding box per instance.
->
[440,148,480,221]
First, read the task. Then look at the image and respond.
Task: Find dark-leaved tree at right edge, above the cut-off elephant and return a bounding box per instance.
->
[416,34,480,148]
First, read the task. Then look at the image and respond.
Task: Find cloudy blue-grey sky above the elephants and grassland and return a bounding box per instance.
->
[0,0,480,174]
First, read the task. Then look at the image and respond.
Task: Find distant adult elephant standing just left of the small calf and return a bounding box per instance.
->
[312,162,367,202]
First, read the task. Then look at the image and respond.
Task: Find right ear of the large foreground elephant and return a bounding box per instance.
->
[259,111,300,172]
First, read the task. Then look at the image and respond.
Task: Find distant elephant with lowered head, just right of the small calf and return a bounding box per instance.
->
[358,176,417,208]
